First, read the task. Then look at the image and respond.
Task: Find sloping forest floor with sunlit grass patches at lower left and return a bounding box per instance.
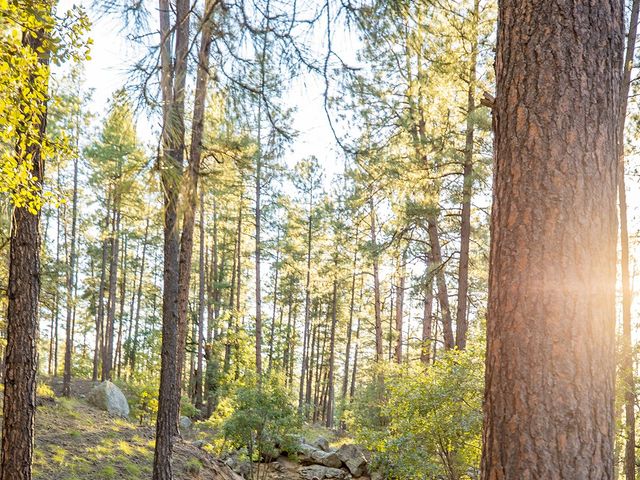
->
[0,381,238,480]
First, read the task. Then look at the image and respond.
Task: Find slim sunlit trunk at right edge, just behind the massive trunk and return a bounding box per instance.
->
[618,0,640,480]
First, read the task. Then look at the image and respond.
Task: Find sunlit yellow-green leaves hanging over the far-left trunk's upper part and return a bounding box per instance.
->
[0,0,91,213]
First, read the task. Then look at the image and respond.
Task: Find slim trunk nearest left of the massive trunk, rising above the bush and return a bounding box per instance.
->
[456,0,480,350]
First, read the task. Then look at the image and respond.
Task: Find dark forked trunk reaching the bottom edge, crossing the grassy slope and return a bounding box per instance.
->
[153,0,191,480]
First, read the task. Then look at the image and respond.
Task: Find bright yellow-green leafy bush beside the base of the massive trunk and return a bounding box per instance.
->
[347,347,484,480]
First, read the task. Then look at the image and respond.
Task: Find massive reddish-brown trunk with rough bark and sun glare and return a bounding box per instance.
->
[482,0,624,479]
